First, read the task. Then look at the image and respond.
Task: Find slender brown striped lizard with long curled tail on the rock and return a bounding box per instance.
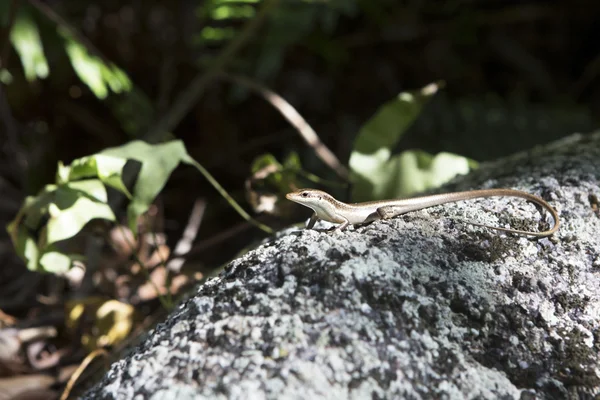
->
[286,189,560,237]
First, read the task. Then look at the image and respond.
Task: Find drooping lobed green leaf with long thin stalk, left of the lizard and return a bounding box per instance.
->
[7,141,272,273]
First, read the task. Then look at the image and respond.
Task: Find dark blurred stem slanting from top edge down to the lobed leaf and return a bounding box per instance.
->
[145,0,278,143]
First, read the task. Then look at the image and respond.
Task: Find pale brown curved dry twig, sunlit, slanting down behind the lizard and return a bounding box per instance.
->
[219,73,349,180]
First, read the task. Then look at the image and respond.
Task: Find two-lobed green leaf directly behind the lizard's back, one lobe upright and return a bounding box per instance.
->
[350,84,476,201]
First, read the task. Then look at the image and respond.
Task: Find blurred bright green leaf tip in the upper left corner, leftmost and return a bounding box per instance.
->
[10,7,50,82]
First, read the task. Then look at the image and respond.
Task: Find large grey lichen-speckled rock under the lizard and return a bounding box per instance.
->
[84,134,600,399]
